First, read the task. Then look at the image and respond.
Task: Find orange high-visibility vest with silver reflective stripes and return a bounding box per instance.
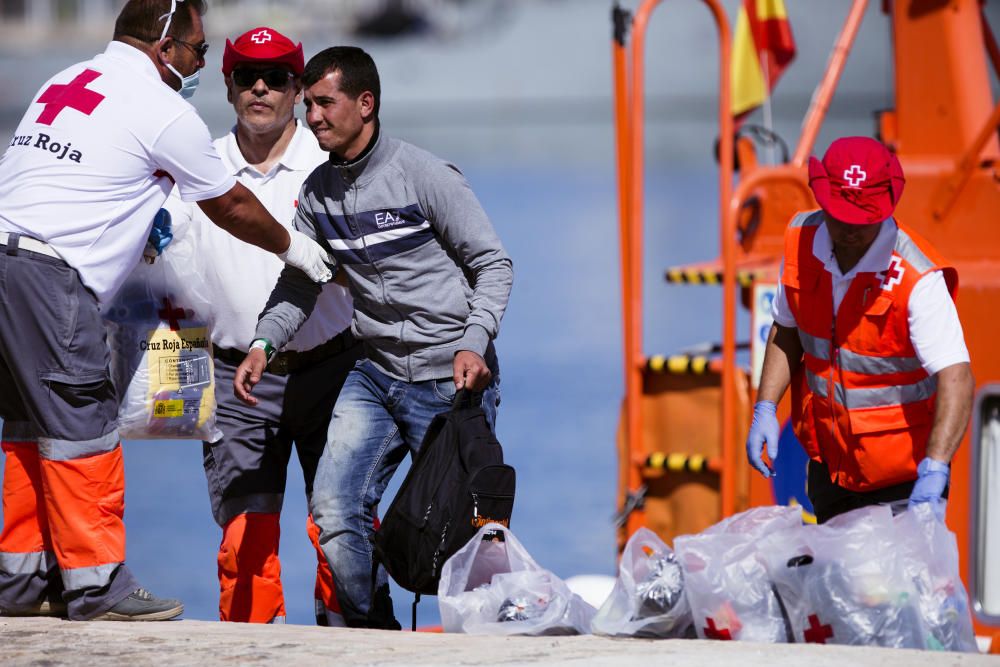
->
[781,211,958,491]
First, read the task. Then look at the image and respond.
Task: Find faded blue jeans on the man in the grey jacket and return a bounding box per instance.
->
[310,360,500,629]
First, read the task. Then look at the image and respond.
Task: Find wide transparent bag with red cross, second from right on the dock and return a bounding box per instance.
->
[760,505,924,648]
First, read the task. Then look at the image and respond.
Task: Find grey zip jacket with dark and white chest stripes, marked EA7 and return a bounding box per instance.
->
[255,135,513,382]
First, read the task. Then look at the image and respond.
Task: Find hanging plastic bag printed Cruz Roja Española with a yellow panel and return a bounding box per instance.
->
[104,224,222,442]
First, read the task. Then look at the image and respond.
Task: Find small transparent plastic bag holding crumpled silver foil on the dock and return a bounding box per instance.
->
[591,528,695,638]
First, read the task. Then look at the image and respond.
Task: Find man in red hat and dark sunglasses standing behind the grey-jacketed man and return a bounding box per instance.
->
[164,27,361,625]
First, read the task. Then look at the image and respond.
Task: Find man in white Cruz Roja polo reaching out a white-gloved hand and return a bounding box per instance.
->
[0,0,330,620]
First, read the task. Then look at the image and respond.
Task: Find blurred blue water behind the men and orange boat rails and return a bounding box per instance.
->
[0,163,718,625]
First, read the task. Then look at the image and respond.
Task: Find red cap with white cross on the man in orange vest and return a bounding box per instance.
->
[809,137,905,225]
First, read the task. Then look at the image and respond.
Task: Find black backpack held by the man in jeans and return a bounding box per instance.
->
[375,390,515,600]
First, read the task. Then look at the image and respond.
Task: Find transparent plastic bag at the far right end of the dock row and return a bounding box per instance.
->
[894,503,978,653]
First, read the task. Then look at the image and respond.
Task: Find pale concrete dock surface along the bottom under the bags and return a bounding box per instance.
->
[0,618,1000,667]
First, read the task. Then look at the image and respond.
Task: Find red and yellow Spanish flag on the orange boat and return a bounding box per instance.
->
[732,0,795,120]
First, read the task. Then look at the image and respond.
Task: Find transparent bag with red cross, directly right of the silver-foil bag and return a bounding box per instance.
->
[674,506,802,643]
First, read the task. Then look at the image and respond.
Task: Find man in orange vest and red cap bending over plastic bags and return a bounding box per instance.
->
[746,137,974,523]
